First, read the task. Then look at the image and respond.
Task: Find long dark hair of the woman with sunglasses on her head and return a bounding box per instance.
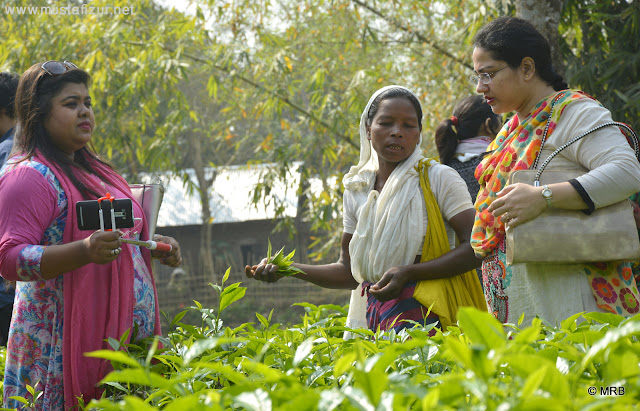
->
[14,63,111,198]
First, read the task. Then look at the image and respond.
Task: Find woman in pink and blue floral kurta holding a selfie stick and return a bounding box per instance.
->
[0,62,182,410]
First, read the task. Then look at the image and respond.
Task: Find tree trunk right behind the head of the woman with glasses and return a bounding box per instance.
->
[516,0,565,75]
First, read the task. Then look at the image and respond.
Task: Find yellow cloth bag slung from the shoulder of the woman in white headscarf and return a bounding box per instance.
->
[413,159,487,331]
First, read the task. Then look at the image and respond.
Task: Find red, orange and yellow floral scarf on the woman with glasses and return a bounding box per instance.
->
[471,90,640,321]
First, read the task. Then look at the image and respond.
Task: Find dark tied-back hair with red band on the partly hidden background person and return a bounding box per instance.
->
[436,96,502,164]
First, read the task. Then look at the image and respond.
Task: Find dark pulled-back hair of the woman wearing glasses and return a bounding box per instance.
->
[473,17,568,91]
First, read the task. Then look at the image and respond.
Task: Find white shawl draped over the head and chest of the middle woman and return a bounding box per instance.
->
[342,85,424,338]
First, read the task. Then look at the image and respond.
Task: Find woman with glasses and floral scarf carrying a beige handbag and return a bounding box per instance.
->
[471,17,640,324]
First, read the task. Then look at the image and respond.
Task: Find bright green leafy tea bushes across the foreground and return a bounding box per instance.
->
[1,272,640,411]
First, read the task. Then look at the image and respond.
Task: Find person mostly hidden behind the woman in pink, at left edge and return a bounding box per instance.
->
[0,73,19,345]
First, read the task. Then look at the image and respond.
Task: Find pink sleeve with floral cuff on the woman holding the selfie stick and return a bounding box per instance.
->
[0,165,60,281]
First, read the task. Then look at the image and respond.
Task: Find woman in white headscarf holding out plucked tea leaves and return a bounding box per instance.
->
[245,86,486,331]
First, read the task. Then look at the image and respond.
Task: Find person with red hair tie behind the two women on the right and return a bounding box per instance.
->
[435,96,502,202]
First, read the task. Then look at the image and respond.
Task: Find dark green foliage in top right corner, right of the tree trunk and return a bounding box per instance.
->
[560,0,640,128]
